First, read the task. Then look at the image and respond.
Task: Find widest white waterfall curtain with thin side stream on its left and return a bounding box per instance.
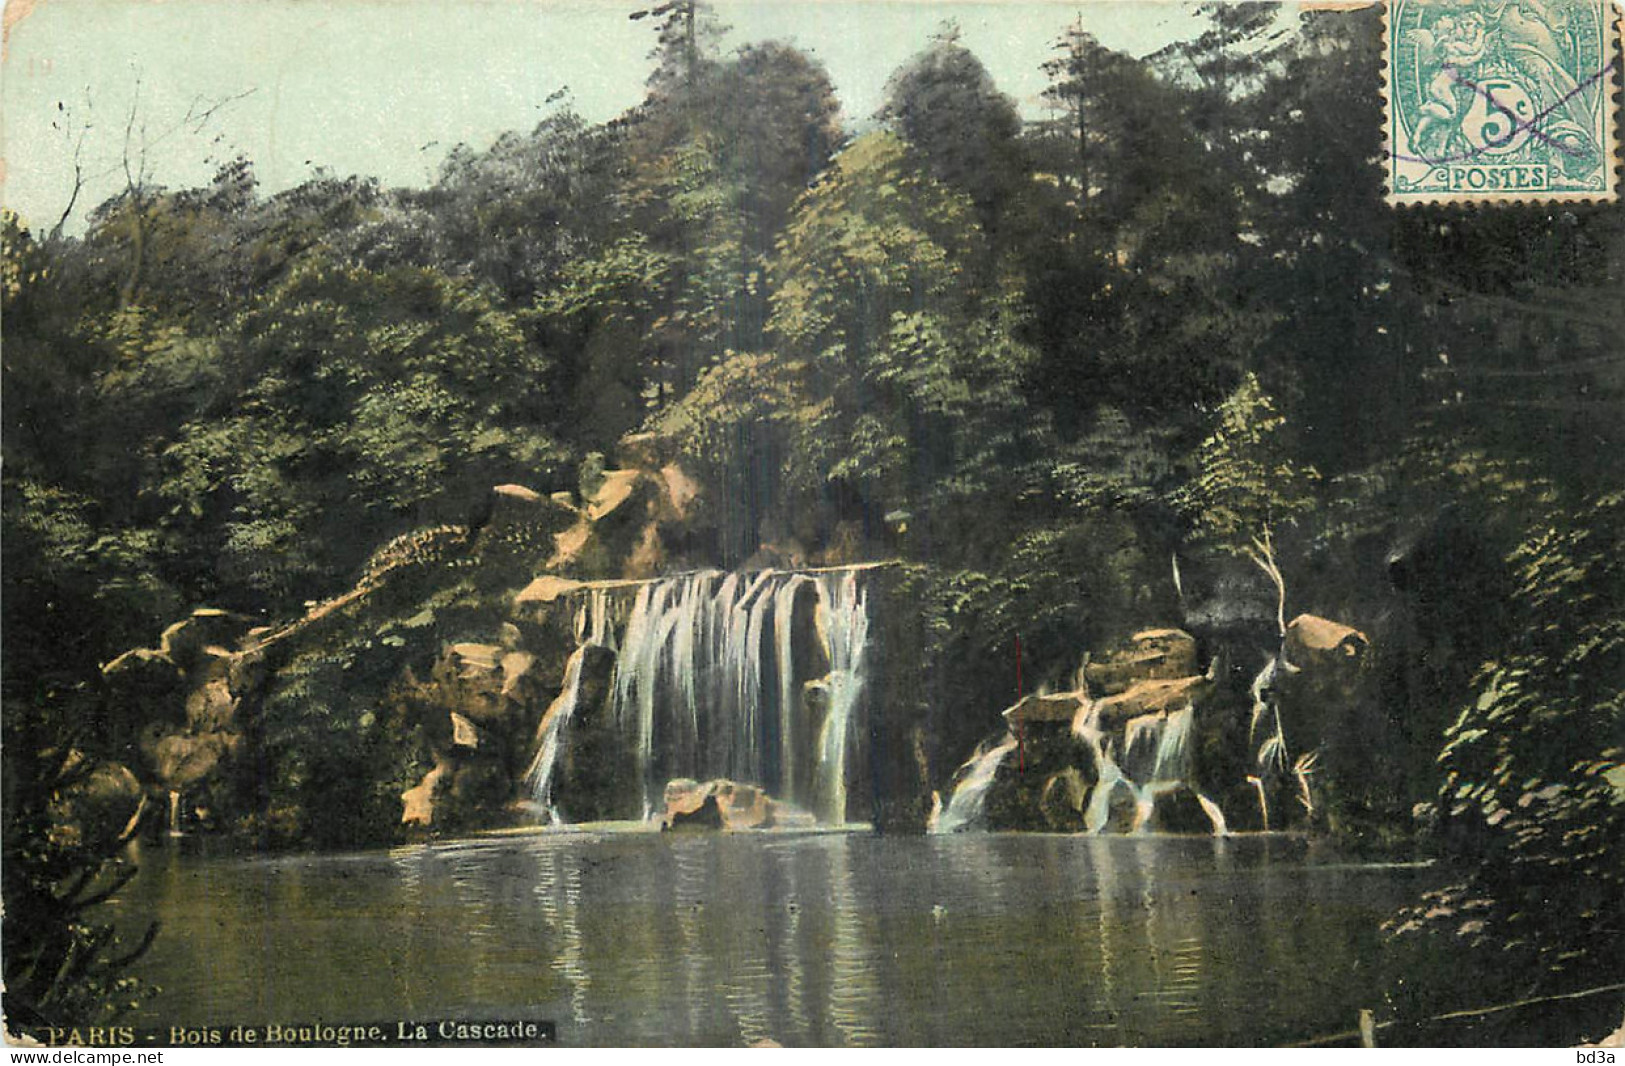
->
[565,569,869,822]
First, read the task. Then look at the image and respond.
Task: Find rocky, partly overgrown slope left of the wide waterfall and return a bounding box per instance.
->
[102,438,715,845]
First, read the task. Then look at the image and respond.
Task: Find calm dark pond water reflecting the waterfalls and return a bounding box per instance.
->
[117,830,1424,1045]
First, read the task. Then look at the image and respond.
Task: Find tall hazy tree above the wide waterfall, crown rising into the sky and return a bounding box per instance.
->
[538,36,840,429]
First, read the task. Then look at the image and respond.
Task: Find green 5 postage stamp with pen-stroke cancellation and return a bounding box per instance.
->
[1385,0,1620,203]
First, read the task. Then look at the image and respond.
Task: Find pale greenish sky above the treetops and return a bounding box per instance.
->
[0,0,1198,232]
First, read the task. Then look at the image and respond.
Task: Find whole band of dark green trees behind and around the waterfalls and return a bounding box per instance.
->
[3,3,1625,1033]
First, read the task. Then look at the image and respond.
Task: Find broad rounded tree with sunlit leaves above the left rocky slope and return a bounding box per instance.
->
[156,254,567,606]
